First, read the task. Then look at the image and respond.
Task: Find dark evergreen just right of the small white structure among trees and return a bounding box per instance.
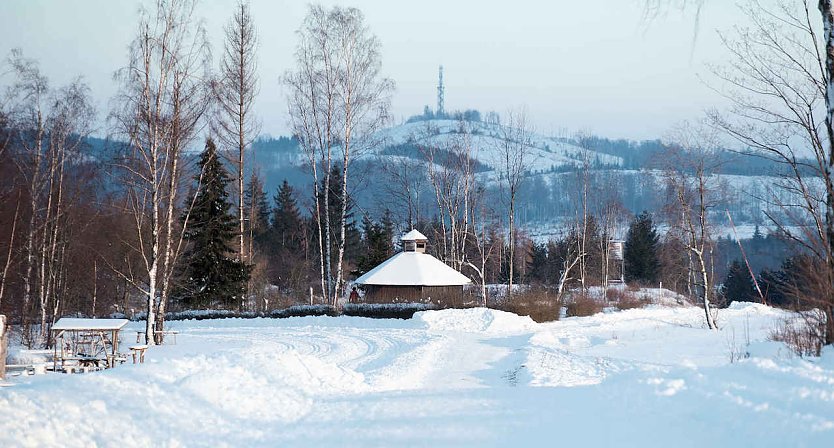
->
[623,211,660,284]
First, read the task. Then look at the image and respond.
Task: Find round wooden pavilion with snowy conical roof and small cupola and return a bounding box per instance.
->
[354,230,471,305]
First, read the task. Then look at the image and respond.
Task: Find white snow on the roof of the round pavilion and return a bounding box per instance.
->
[355,252,471,286]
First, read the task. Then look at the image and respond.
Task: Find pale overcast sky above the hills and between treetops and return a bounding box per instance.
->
[0,0,744,139]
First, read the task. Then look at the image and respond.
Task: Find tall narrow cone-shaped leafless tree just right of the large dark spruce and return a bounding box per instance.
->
[212,2,260,276]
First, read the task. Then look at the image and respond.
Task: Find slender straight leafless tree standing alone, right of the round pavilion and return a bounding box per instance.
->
[499,110,533,300]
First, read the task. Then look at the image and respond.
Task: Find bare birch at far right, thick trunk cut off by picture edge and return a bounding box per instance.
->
[646,0,834,345]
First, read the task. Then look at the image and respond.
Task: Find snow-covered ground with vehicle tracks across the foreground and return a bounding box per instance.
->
[0,304,834,447]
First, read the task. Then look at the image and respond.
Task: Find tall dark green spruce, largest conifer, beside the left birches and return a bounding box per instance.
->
[182,139,249,308]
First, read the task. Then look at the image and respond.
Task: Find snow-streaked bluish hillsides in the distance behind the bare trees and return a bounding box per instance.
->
[253,119,822,229]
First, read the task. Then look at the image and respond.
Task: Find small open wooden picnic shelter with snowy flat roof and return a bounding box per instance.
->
[52,317,128,371]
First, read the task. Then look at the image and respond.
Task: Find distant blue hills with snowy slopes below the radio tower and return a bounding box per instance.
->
[81,116,816,234]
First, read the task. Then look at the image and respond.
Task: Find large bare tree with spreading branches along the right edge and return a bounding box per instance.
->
[711,0,834,344]
